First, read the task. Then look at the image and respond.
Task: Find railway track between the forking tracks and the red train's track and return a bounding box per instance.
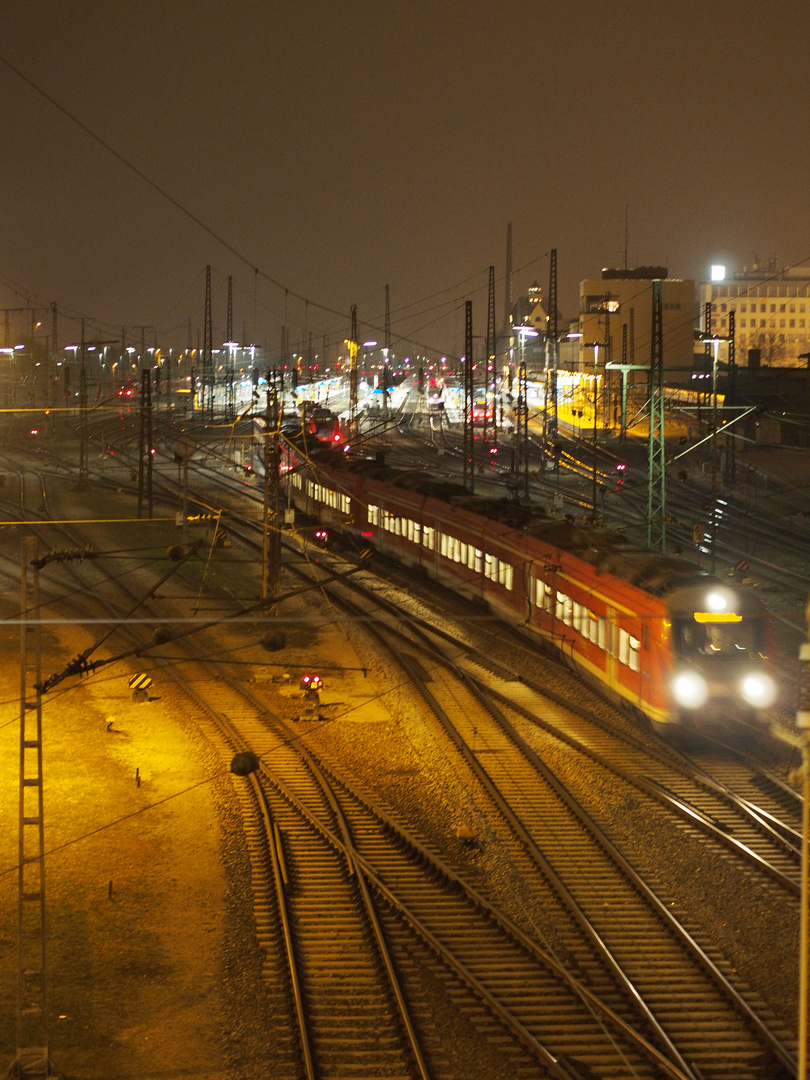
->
[282,548,793,1077]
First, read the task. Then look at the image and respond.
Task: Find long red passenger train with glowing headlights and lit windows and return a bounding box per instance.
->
[288,455,777,730]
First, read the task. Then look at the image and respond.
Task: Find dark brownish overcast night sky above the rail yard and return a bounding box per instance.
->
[0,0,810,352]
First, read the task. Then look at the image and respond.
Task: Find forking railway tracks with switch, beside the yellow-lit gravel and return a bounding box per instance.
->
[1,462,688,1080]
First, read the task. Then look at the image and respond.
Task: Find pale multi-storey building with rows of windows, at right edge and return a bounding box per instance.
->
[700,262,810,367]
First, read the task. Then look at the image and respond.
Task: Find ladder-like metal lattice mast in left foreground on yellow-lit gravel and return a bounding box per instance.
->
[9,537,55,1077]
